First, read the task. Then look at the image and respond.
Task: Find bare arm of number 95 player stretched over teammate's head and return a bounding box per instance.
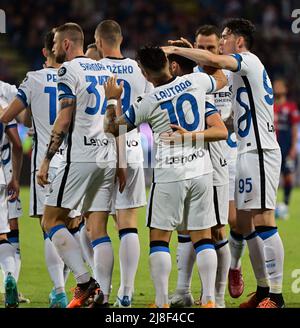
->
[162,46,238,72]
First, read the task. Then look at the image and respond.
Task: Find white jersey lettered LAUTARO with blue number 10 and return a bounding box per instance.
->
[126,73,216,182]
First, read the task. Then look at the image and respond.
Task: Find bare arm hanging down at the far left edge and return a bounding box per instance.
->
[6,127,23,200]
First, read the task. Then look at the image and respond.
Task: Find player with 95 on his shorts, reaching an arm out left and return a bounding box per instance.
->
[165,19,284,308]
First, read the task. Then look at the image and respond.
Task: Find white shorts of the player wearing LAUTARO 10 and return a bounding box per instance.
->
[147,173,217,231]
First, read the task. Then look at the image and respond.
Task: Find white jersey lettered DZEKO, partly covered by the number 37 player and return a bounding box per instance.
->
[99,57,153,164]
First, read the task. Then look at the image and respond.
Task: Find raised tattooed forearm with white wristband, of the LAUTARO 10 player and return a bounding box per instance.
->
[104,76,134,137]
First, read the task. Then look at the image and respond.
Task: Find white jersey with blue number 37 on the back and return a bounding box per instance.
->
[58,57,115,163]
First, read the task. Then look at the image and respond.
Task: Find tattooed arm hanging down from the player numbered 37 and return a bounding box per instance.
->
[37,98,76,186]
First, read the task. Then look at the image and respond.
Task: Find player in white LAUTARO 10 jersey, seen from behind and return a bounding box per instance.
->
[105,47,227,307]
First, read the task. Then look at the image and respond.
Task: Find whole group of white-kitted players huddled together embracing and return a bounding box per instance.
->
[0,19,284,308]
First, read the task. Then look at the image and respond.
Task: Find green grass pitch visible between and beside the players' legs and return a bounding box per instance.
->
[1,187,300,308]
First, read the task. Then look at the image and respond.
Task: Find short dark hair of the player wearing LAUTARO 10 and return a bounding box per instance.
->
[136,46,168,72]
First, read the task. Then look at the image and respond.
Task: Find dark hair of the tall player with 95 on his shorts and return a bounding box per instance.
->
[224,18,255,50]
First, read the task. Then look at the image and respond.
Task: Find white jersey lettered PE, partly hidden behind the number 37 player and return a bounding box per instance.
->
[17,67,63,172]
